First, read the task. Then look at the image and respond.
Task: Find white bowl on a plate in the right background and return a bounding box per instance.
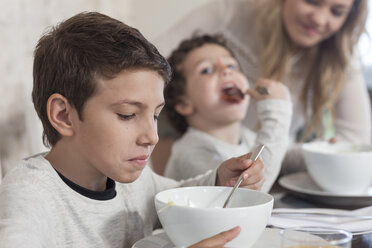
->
[302,142,372,195]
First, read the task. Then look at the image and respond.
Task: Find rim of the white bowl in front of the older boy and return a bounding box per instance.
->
[154,185,274,212]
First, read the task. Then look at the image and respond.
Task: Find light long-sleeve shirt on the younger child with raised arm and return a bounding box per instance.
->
[165,99,292,192]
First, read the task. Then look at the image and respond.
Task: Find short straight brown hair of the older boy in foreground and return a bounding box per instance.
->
[32,12,171,146]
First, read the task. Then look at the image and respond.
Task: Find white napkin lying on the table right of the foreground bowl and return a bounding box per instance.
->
[268,206,372,234]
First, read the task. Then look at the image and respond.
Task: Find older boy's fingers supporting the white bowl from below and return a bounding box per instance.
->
[189,226,240,248]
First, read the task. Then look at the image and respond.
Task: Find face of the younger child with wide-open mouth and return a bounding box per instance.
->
[182,44,249,127]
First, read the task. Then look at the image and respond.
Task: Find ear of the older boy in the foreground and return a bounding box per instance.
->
[47,93,74,136]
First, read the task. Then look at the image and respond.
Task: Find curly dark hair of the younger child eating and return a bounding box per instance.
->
[164,34,238,134]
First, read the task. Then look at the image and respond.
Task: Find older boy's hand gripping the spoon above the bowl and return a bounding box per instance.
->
[216,152,265,190]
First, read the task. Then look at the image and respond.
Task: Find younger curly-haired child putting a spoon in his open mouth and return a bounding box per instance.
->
[164,35,292,192]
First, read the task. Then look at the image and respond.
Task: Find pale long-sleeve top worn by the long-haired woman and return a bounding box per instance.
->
[153,0,372,170]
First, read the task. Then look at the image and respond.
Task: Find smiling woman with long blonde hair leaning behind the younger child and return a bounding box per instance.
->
[152,0,372,176]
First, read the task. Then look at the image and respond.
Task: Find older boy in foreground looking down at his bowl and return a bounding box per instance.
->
[0,12,264,247]
